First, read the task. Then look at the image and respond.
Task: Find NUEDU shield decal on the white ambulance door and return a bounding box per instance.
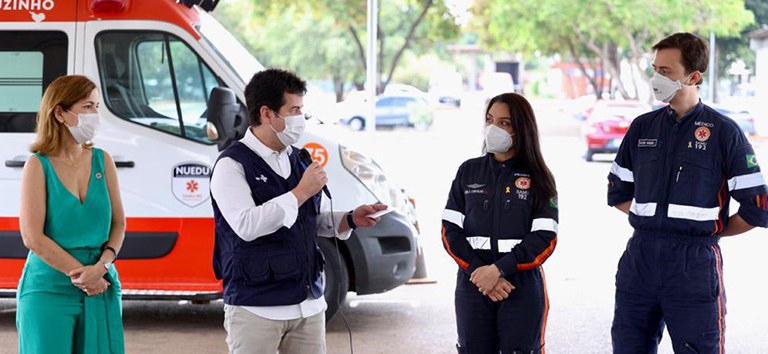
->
[171,162,211,208]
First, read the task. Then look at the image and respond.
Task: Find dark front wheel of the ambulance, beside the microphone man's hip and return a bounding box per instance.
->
[318,239,349,322]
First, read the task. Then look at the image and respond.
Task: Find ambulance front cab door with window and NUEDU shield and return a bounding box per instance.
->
[85,21,225,297]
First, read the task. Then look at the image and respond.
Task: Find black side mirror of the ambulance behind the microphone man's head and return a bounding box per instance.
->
[206,87,248,151]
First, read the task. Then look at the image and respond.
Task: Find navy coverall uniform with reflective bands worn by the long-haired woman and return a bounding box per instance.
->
[442,154,558,354]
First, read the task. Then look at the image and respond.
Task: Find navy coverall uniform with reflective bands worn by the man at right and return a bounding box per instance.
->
[608,102,768,354]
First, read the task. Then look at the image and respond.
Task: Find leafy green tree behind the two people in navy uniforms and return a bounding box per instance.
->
[475,0,753,98]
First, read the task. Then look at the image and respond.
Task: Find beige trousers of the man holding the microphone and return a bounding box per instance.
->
[224,306,325,354]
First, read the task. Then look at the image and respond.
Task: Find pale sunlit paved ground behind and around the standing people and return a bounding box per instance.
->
[0,102,768,354]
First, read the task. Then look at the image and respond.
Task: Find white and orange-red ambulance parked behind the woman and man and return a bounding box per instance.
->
[0,0,418,318]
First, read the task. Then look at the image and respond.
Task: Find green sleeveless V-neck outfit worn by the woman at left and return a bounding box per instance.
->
[16,148,125,354]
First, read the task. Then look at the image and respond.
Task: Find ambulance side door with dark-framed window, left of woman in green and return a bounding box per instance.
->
[0,14,76,290]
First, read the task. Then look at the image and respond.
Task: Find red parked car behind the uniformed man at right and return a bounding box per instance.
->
[582,101,651,161]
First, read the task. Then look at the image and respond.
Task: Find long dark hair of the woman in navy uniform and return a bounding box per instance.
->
[483,93,557,210]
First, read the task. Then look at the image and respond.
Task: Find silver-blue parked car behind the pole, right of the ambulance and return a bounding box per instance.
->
[339,94,432,131]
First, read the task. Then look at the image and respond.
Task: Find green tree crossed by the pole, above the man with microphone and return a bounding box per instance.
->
[216,0,459,99]
